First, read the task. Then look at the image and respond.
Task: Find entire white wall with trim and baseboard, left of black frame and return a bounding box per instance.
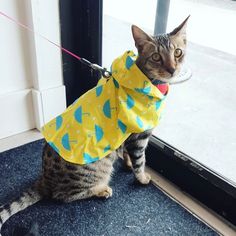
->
[0,0,66,138]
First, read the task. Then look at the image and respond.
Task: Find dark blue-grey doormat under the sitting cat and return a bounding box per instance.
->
[0,140,217,236]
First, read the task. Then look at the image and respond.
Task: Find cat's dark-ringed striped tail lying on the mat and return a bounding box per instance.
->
[0,185,42,236]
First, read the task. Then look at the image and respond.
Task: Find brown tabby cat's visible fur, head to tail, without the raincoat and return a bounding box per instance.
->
[0,17,189,234]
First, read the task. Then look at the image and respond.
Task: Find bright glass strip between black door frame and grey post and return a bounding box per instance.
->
[103,0,157,68]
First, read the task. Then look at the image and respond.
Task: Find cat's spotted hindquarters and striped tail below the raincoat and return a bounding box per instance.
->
[0,143,117,232]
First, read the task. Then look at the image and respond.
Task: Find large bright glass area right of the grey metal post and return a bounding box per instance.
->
[154,0,236,186]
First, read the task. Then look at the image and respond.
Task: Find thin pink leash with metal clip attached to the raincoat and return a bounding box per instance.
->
[0,11,111,78]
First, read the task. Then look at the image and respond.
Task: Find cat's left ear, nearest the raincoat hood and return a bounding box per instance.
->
[131,25,153,53]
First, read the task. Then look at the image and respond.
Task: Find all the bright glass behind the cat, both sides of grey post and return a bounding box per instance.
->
[103,0,236,183]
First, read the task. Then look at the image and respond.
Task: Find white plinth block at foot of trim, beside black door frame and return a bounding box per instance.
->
[32,85,66,130]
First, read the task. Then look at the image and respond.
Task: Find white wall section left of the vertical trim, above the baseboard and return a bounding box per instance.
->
[0,0,32,95]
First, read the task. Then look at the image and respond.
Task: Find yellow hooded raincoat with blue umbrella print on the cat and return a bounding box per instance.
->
[42,51,168,165]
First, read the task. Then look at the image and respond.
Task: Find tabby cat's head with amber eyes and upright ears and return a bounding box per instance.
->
[132,17,189,82]
